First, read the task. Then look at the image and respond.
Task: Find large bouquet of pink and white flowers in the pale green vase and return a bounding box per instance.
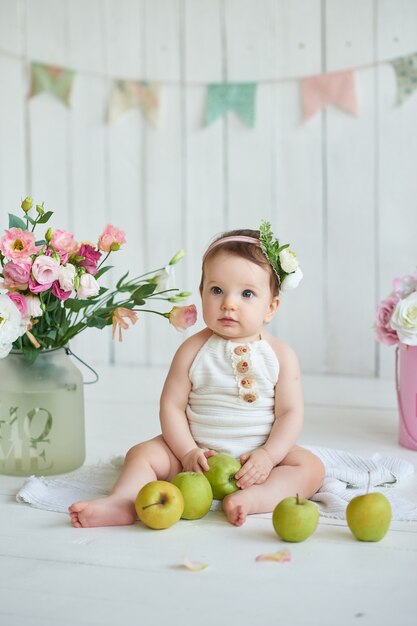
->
[0,197,196,362]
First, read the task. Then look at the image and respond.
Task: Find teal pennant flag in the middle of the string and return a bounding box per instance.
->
[205,83,256,128]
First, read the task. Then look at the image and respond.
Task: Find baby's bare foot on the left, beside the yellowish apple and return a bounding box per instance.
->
[68,496,136,528]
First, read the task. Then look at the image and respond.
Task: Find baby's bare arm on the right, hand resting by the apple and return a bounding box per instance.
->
[236,338,304,488]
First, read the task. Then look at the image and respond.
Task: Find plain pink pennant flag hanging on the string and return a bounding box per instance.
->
[301,70,358,120]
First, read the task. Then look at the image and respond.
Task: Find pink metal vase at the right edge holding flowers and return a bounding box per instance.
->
[395,343,417,450]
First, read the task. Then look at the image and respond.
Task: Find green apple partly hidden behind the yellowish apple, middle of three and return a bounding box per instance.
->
[172,472,213,519]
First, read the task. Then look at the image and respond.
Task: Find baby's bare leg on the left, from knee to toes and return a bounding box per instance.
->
[69,435,181,528]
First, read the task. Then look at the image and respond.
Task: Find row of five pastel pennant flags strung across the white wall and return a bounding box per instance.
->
[29,52,417,128]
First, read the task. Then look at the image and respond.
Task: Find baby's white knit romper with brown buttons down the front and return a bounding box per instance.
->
[187,335,279,458]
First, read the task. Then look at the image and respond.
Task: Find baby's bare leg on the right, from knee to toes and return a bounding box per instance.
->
[223,446,324,526]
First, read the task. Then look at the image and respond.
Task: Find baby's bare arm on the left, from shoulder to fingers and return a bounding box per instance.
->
[160,330,214,472]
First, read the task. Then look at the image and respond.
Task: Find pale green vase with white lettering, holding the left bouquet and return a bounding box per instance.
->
[0,348,85,476]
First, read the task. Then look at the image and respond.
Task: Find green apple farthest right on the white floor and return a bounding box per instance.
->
[346,493,391,541]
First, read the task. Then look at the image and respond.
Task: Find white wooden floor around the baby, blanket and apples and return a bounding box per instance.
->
[0,368,417,626]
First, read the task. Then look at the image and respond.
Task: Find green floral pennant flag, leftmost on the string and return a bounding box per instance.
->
[29,61,75,106]
